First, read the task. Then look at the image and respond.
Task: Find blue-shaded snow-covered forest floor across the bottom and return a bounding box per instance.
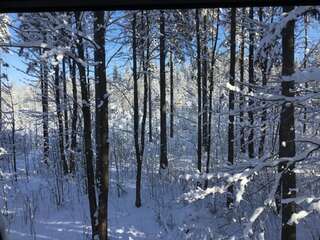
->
[0,150,319,240]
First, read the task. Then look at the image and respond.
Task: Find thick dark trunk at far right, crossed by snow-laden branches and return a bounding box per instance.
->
[279,7,296,240]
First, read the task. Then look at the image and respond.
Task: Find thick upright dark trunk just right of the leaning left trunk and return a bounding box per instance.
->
[94,11,109,240]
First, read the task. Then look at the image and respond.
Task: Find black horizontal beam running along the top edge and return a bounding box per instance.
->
[0,0,319,12]
